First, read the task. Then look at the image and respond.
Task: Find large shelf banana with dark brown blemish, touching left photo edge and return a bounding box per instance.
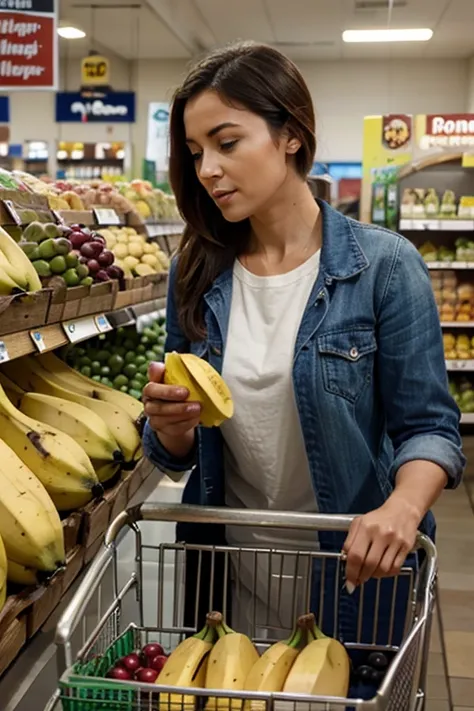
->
[0,386,102,508]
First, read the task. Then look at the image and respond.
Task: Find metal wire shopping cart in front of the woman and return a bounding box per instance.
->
[45,504,437,711]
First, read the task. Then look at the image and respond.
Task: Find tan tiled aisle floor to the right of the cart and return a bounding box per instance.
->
[426,468,474,711]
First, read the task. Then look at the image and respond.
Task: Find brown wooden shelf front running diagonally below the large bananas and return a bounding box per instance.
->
[0,459,153,676]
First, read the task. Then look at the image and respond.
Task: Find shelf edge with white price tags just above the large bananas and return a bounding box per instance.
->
[0,298,166,363]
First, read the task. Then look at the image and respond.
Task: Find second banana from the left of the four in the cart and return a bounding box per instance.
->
[205,613,259,711]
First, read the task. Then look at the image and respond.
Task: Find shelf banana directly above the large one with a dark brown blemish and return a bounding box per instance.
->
[20,393,123,464]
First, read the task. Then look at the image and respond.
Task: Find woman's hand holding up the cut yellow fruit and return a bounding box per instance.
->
[143,363,201,442]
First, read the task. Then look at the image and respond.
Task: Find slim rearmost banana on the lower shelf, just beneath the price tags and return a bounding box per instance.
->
[38,353,143,428]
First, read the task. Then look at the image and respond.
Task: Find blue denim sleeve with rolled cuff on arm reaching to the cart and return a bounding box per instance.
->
[378,238,466,488]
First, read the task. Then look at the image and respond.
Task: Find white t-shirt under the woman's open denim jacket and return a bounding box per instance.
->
[221,251,320,626]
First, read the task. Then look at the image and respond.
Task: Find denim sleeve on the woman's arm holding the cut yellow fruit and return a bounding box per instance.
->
[143,260,197,479]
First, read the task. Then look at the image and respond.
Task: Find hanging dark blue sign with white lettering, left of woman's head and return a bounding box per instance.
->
[56,91,135,123]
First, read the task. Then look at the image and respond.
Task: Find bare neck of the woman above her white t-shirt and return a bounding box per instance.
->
[241,178,322,273]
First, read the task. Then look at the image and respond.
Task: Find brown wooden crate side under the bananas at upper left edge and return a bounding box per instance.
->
[0,289,52,336]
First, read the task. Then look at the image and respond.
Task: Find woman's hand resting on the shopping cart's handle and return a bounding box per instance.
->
[344,495,420,590]
